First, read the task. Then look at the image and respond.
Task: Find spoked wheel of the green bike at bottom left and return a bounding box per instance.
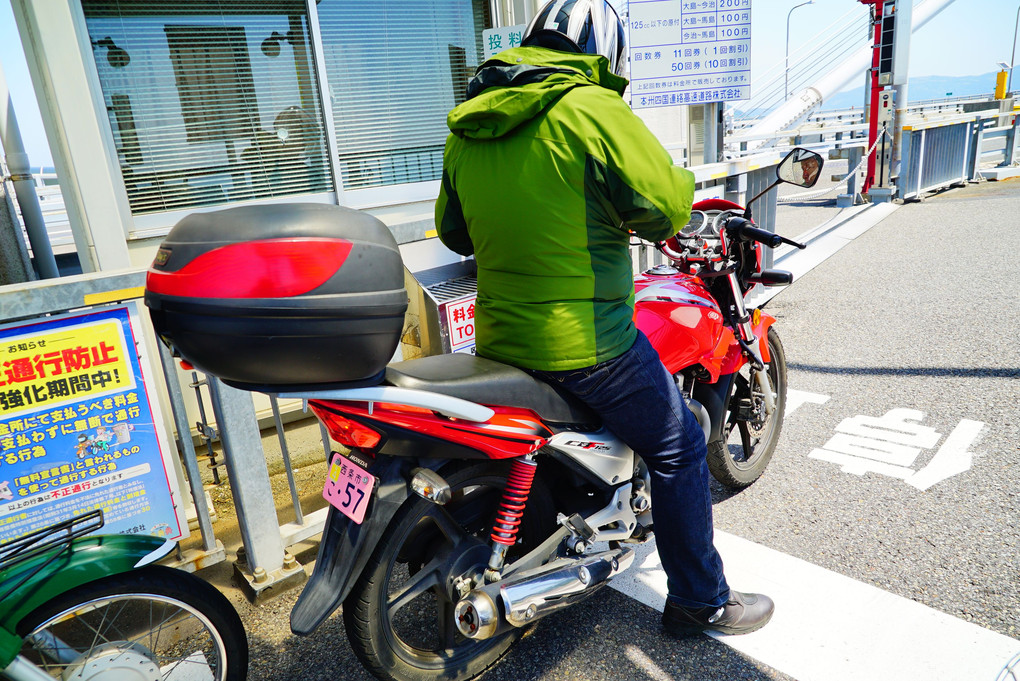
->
[17,566,248,681]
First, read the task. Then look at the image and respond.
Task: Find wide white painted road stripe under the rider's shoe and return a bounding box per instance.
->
[611,531,1020,681]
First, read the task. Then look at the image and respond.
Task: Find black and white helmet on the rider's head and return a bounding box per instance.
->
[521,0,626,75]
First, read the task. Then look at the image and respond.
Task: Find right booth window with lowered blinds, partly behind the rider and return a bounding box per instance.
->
[317,0,491,190]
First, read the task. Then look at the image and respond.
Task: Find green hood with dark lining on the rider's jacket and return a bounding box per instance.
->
[447,47,627,140]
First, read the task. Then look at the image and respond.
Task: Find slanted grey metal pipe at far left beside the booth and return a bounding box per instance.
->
[0,59,60,279]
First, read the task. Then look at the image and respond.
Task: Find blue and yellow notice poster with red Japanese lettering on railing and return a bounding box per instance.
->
[0,303,188,542]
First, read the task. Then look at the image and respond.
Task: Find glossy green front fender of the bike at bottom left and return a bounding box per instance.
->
[0,534,165,648]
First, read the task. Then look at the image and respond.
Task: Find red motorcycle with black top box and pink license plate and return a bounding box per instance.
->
[146,149,821,681]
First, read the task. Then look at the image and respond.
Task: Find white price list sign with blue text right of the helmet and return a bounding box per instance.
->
[629,0,751,109]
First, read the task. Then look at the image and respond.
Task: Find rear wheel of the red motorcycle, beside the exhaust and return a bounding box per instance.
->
[344,462,555,681]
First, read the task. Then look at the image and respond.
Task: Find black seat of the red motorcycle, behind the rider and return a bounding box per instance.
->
[386,353,600,426]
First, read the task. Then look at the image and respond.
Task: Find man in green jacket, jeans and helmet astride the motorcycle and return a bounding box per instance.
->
[436,0,773,634]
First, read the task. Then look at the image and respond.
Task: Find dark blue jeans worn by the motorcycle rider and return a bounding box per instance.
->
[531,331,729,608]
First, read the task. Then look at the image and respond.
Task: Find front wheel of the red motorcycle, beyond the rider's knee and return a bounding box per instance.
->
[708,328,786,490]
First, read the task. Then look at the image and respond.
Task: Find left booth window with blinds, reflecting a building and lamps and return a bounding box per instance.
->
[82,0,334,215]
